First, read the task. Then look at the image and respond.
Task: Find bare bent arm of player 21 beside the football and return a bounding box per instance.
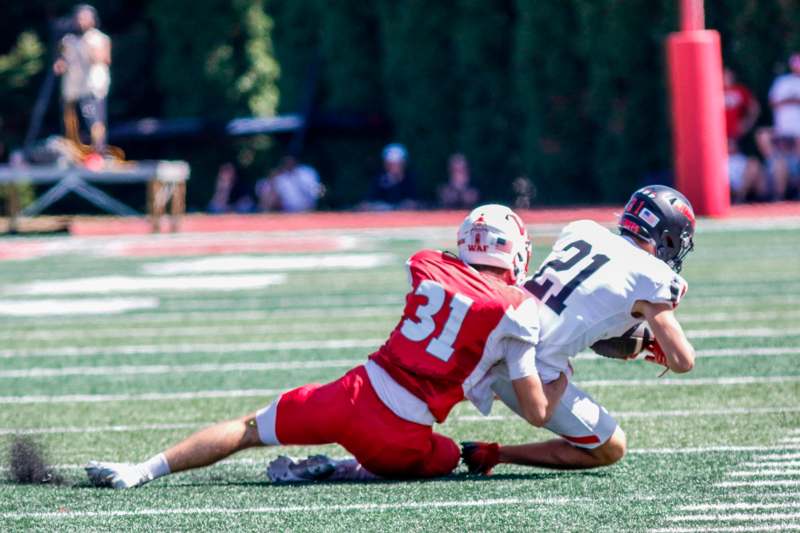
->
[633,300,694,374]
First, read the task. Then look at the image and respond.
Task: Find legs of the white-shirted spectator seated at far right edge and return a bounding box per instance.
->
[756,128,800,200]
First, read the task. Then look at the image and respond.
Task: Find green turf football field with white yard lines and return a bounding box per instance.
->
[0,218,800,532]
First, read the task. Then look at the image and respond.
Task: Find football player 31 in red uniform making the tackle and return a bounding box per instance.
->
[86,205,567,488]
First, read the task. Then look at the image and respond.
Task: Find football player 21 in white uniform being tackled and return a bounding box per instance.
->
[462,185,695,474]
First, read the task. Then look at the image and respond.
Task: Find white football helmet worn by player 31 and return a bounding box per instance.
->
[458,204,531,284]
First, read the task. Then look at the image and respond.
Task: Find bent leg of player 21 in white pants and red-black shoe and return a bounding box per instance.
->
[463,380,627,473]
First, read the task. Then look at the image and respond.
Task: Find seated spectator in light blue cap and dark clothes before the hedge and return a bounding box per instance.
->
[361,143,417,211]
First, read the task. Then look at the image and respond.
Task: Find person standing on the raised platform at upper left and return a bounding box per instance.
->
[53,4,111,153]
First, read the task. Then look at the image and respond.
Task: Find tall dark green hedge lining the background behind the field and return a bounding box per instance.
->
[0,0,800,207]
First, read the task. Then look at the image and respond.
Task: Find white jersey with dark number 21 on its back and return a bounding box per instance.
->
[525,220,687,383]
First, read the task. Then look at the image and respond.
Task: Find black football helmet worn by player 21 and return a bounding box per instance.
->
[619,185,694,272]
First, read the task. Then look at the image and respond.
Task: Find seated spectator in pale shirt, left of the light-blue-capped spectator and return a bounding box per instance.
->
[256,155,323,213]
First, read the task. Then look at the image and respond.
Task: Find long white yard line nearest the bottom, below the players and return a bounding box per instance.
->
[0,497,584,520]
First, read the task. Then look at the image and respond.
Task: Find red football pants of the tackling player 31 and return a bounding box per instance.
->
[275,366,460,478]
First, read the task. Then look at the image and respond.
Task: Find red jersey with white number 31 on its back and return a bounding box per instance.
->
[370,250,538,422]
